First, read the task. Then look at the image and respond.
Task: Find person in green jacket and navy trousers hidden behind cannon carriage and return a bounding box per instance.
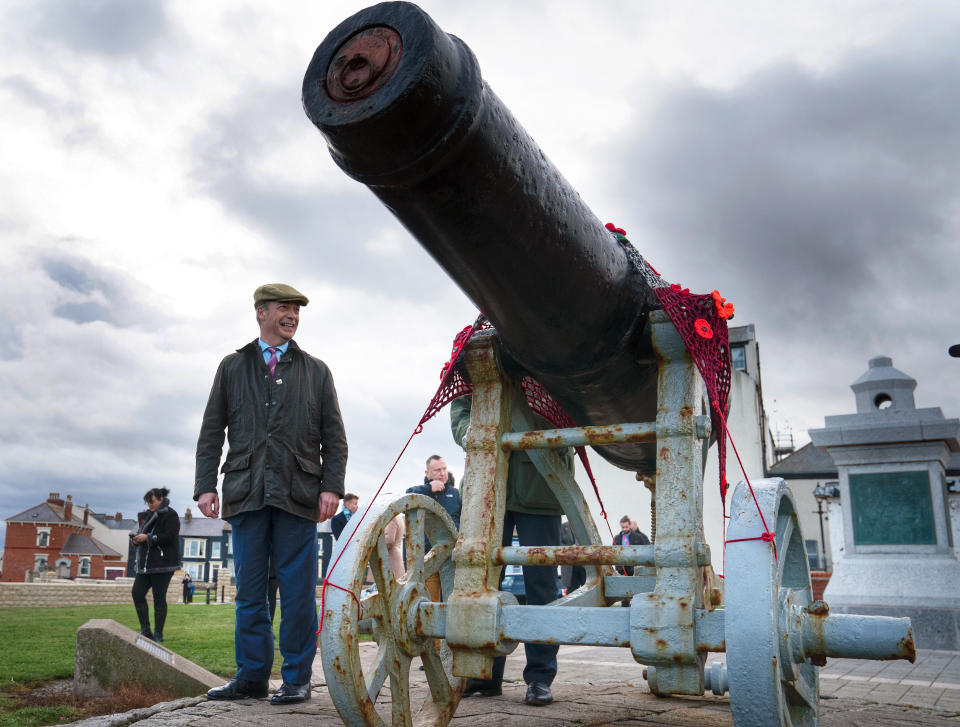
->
[450,396,573,706]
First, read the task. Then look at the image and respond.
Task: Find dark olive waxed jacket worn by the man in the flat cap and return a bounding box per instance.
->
[193,340,347,520]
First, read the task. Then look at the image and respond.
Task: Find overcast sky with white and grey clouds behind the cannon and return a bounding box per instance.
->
[0,0,960,560]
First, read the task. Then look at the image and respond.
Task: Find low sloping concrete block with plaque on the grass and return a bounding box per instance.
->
[73,619,224,697]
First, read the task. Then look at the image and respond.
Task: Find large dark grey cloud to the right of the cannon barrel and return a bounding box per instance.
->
[621,30,960,343]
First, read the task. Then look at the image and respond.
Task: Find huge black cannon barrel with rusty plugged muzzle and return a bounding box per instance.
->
[303,2,658,472]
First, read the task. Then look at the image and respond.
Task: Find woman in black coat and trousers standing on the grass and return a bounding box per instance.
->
[130,487,180,642]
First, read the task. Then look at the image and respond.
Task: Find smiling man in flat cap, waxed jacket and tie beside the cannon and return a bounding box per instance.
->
[193,283,347,704]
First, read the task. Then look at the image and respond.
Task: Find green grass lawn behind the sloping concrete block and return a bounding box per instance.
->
[0,603,282,688]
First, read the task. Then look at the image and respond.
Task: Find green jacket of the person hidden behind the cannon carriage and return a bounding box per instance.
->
[450,396,573,515]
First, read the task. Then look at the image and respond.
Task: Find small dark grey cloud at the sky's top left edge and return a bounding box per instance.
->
[29,0,168,56]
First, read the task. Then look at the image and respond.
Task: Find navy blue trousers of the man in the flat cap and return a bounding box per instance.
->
[228,507,318,685]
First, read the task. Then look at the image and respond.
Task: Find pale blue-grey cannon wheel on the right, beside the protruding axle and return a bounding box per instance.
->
[724,478,820,727]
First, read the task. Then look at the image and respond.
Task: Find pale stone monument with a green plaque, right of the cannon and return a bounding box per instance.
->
[810,356,960,649]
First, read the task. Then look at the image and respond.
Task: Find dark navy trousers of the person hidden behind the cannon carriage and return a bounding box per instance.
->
[493,510,560,686]
